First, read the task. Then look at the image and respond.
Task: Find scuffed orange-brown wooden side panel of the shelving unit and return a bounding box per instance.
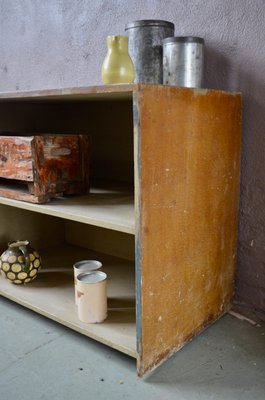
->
[136,86,241,375]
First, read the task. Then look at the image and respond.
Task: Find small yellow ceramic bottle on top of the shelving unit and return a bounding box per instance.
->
[101,36,134,85]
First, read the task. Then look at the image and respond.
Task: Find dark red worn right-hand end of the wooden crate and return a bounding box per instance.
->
[32,135,89,198]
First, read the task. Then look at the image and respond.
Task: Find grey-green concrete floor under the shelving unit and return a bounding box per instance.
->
[0,298,265,400]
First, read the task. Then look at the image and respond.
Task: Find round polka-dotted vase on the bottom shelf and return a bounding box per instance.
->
[0,240,41,285]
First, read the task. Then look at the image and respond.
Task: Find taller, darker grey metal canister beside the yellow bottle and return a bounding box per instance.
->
[125,20,174,83]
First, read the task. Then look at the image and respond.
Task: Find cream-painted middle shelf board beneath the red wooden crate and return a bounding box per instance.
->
[0,187,135,234]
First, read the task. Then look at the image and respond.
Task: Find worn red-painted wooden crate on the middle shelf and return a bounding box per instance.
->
[0,134,89,203]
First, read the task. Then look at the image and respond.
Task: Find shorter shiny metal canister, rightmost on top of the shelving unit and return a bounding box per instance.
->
[163,36,204,88]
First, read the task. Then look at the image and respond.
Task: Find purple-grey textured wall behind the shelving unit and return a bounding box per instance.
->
[0,0,265,311]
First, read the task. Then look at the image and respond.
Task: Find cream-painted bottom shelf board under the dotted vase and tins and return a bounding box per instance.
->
[0,246,137,358]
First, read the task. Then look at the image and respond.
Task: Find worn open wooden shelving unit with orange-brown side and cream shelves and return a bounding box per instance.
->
[0,85,241,376]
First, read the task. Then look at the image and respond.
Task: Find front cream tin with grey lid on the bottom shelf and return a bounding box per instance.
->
[77,271,107,324]
